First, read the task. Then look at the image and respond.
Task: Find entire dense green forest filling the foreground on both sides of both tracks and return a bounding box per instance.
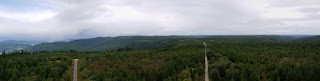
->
[0,36,320,81]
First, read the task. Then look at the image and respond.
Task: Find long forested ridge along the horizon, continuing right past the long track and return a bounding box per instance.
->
[27,35,312,51]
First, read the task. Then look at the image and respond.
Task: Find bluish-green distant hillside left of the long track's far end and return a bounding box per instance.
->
[27,36,181,51]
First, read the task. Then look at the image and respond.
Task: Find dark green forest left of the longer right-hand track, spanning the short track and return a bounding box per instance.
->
[0,38,204,81]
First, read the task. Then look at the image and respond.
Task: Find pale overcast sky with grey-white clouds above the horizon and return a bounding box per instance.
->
[0,0,320,40]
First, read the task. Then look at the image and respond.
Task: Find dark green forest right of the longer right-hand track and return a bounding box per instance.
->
[201,38,320,81]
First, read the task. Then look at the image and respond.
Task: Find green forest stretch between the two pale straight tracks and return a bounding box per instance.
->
[79,44,204,81]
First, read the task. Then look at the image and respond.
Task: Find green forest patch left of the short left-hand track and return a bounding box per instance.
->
[0,53,71,81]
